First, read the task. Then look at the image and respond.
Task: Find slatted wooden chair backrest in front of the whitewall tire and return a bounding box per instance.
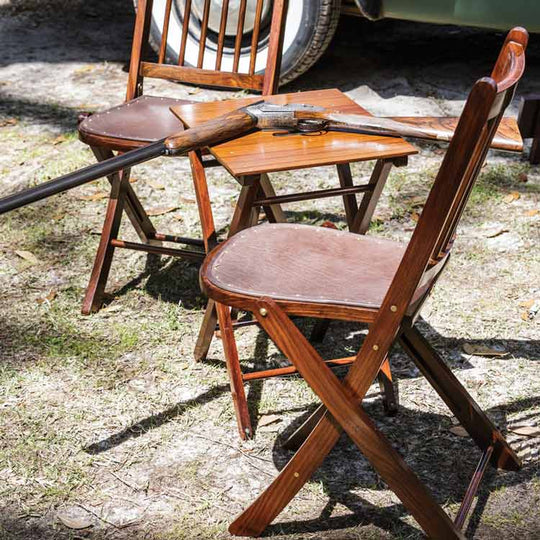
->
[126,0,288,100]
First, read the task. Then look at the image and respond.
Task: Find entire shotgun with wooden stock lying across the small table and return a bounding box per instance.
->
[0,100,523,214]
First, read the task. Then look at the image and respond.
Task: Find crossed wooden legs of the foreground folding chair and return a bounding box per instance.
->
[229,298,520,539]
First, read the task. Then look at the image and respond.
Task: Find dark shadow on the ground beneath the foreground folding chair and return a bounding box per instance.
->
[265,398,540,538]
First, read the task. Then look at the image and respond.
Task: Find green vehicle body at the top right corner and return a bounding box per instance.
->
[356,0,540,32]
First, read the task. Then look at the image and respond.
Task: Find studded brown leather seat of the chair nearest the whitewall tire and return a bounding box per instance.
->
[79,96,191,150]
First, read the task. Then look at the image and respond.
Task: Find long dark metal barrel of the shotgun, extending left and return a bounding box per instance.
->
[0,139,167,214]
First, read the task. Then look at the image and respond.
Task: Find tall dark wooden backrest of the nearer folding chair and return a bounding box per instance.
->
[382,28,528,318]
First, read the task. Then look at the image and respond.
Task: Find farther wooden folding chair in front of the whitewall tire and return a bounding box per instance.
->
[79,0,288,314]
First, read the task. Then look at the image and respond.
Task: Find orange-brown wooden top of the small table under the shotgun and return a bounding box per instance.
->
[171,89,417,177]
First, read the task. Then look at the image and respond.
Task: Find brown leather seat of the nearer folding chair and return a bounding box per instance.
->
[203,223,404,309]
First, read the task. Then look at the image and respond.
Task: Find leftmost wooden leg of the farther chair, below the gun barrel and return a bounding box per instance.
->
[82,171,128,315]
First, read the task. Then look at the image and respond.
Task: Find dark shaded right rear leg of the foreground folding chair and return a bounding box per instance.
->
[399,326,521,470]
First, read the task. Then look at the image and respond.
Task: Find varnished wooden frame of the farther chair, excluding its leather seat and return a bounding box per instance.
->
[80,0,287,312]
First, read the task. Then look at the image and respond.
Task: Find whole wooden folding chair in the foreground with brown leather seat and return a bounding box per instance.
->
[201,28,528,539]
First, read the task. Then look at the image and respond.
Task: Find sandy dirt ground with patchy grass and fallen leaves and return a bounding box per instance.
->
[0,0,540,540]
